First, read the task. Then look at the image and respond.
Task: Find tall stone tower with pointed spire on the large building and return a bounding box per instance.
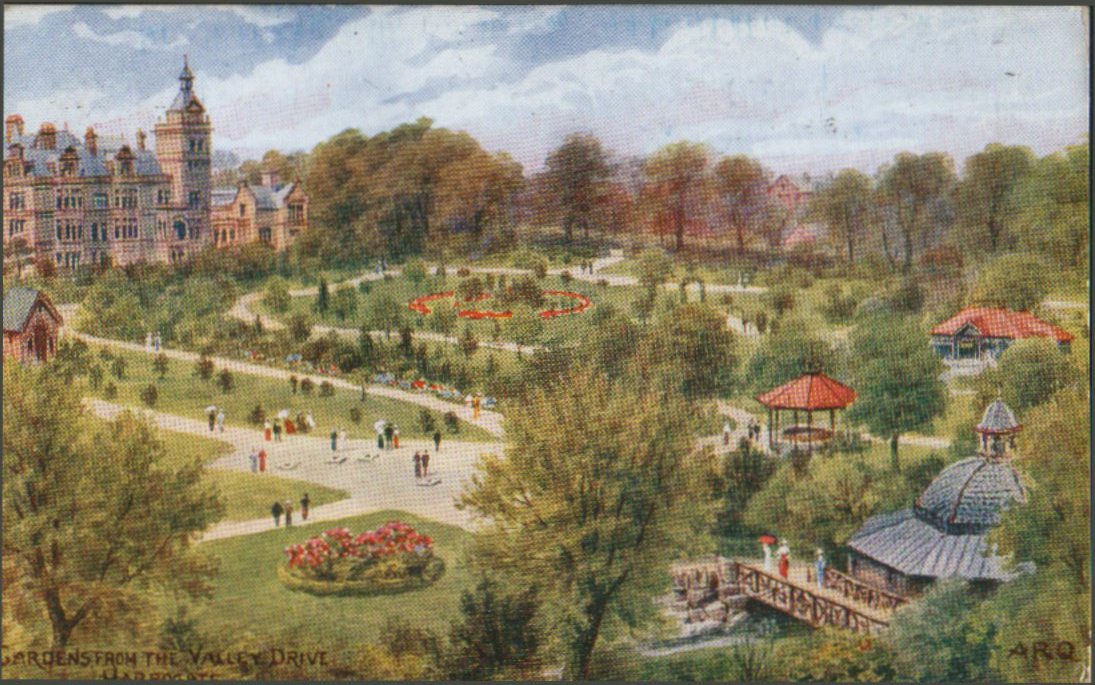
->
[154,57,212,262]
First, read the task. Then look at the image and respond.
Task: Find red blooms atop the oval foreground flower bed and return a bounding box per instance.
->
[285,521,434,576]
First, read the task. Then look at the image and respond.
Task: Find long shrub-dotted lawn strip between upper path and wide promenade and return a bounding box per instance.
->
[87,341,494,442]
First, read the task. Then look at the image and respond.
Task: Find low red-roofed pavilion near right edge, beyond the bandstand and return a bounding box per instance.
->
[932,306,1073,360]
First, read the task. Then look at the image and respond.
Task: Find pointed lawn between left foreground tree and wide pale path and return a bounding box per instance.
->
[160,430,349,521]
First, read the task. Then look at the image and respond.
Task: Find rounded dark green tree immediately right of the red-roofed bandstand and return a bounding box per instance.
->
[848,313,946,471]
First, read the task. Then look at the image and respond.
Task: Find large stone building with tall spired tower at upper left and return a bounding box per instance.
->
[3,61,306,269]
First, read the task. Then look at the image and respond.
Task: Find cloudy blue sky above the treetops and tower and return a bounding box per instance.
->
[3,4,1090,175]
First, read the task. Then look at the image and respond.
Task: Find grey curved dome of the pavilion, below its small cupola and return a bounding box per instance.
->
[913,456,1026,533]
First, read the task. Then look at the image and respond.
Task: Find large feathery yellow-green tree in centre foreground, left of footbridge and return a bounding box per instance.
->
[460,370,710,680]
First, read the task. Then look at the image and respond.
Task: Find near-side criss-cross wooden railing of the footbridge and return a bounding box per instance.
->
[734,564,889,635]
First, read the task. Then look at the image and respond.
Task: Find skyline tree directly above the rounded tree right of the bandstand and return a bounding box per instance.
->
[878,152,955,270]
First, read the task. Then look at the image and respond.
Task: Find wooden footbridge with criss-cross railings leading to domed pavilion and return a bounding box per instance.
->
[673,559,909,635]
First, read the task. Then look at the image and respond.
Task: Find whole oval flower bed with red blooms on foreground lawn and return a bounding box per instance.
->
[277,521,445,595]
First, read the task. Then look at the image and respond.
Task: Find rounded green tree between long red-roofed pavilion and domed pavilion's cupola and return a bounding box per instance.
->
[978,338,1081,415]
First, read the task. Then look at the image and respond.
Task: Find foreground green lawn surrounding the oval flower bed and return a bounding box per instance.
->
[187,511,471,654]
